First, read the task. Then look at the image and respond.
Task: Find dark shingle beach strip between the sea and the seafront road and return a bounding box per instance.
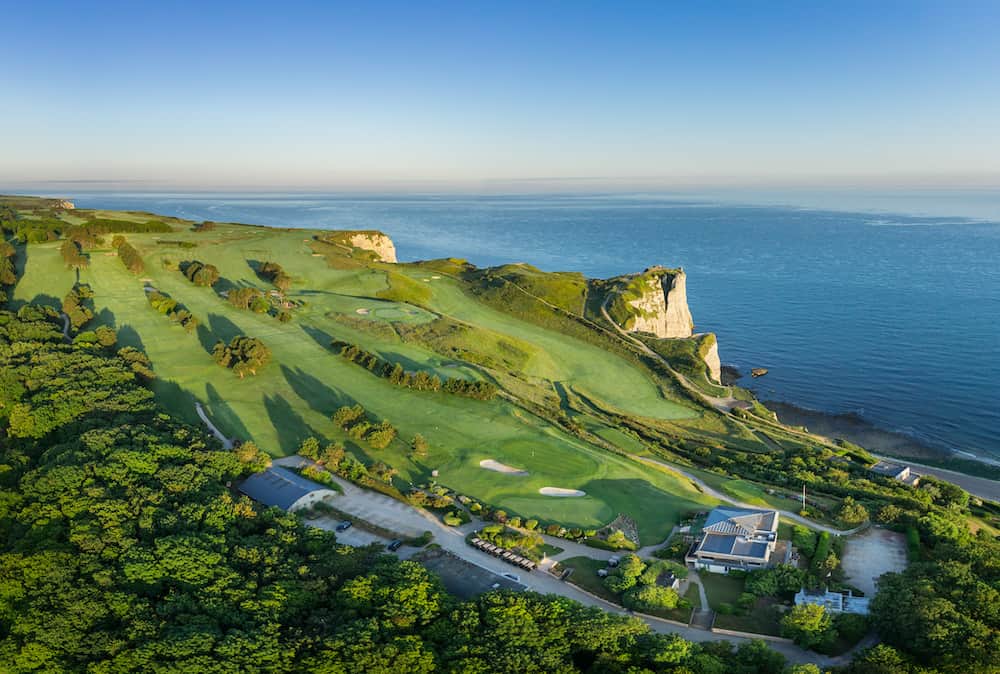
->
[762,400,1000,502]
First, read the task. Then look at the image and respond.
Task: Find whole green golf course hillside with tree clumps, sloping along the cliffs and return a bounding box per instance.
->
[0,198,988,544]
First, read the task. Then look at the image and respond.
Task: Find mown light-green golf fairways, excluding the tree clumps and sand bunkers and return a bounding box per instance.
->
[14,225,714,544]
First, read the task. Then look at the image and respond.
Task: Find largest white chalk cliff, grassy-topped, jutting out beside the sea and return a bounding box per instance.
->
[617,267,694,339]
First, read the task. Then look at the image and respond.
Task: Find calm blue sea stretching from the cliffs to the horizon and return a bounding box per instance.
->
[43,193,1000,458]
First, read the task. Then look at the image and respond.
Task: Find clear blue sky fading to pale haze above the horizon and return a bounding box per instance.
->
[0,0,1000,191]
